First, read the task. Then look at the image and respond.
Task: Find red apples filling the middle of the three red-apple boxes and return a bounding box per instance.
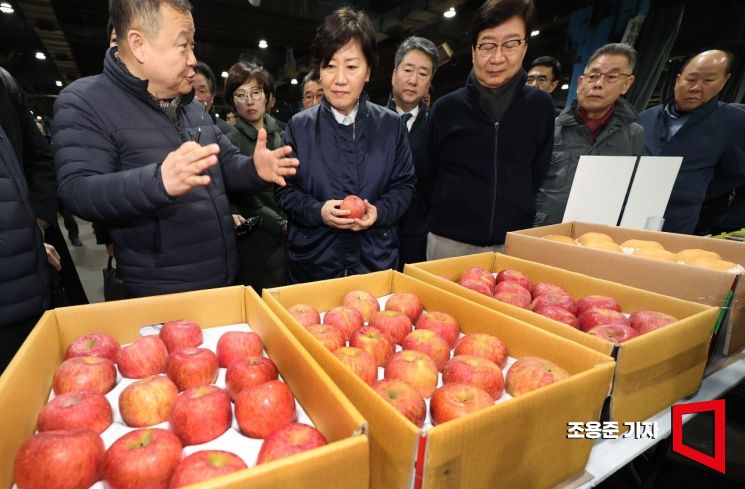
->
[287,290,569,428]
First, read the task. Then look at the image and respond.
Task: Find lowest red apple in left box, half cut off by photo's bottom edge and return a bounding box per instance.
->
[169,450,248,489]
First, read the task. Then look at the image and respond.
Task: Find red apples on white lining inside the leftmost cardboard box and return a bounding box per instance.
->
[13,320,326,489]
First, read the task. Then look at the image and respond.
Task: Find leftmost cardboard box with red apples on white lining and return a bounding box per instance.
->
[0,287,369,489]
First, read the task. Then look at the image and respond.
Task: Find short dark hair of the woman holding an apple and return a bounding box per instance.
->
[311,7,378,70]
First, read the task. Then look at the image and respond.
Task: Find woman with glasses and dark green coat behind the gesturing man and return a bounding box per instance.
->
[225,62,287,292]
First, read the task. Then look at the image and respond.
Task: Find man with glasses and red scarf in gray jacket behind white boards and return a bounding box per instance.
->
[533,44,644,226]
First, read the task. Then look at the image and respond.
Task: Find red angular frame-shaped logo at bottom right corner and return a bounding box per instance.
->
[672,399,725,474]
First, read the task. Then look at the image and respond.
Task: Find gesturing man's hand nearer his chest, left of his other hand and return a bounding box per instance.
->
[160,141,220,197]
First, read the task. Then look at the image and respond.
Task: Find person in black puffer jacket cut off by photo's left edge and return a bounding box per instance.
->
[0,68,59,373]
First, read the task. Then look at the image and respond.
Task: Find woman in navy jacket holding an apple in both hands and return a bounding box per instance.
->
[276,7,415,282]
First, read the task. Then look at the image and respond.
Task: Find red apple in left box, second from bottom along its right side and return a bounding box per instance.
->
[235,380,297,438]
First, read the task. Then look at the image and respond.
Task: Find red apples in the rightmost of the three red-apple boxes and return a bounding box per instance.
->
[458,267,677,344]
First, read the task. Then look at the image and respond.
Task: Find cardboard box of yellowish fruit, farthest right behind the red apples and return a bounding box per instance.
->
[505,221,745,358]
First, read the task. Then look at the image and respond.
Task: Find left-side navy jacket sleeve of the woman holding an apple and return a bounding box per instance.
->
[274,119,324,228]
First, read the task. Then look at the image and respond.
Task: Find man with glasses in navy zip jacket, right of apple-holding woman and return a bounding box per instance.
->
[417,0,554,260]
